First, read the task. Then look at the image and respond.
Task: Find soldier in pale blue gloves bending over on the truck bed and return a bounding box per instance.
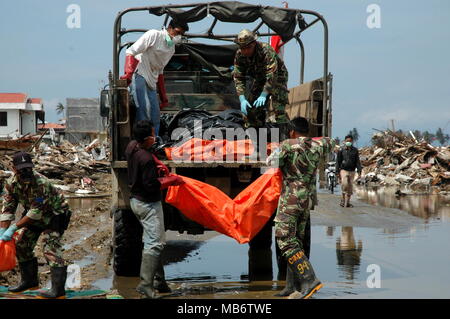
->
[233,29,289,140]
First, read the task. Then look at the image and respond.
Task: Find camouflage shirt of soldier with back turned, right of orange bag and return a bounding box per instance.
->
[271,137,336,195]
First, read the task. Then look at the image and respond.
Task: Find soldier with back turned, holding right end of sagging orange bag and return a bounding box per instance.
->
[268,117,335,298]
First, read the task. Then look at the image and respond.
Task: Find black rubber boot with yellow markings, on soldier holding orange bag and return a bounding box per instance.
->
[287,250,323,299]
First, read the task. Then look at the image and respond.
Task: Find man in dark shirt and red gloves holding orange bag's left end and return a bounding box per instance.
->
[125,120,184,299]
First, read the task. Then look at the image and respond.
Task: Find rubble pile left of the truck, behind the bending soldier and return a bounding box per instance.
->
[0,139,110,195]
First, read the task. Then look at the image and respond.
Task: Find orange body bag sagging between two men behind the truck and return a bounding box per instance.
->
[166,169,282,244]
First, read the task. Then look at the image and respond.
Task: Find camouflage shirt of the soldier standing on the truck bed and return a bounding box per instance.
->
[233,42,288,95]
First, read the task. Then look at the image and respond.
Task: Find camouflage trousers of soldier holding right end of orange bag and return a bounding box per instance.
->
[274,185,311,257]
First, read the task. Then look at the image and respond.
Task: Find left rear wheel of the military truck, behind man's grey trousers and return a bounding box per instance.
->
[113,209,143,277]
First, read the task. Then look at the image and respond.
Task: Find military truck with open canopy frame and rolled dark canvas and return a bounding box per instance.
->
[100,2,332,276]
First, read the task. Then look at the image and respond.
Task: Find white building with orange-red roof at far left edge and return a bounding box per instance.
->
[0,93,44,138]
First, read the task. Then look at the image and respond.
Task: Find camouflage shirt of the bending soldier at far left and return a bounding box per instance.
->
[0,172,69,224]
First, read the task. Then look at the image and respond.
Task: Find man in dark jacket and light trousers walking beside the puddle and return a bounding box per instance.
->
[336,135,362,207]
